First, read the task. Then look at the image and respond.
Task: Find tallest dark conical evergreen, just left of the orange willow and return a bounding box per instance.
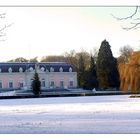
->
[96,40,119,89]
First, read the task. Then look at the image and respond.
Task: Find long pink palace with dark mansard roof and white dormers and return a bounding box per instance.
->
[0,62,77,90]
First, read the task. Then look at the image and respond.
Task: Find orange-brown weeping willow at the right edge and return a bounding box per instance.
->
[118,51,140,92]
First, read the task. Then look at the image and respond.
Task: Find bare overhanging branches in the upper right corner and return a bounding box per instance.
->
[111,6,140,31]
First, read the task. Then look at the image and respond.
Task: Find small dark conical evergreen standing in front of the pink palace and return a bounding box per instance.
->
[31,71,41,96]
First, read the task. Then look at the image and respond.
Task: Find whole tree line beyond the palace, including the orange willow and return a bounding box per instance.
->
[6,40,140,91]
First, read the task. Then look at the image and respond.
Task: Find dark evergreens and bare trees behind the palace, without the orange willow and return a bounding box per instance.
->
[6,40,139,90]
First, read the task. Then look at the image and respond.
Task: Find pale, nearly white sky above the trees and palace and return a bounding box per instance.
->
[0,7,140,61]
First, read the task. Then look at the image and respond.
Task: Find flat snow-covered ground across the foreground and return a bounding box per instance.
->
[0,95,140,134]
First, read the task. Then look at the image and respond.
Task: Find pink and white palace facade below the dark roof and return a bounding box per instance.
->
[0,63,77,89]
